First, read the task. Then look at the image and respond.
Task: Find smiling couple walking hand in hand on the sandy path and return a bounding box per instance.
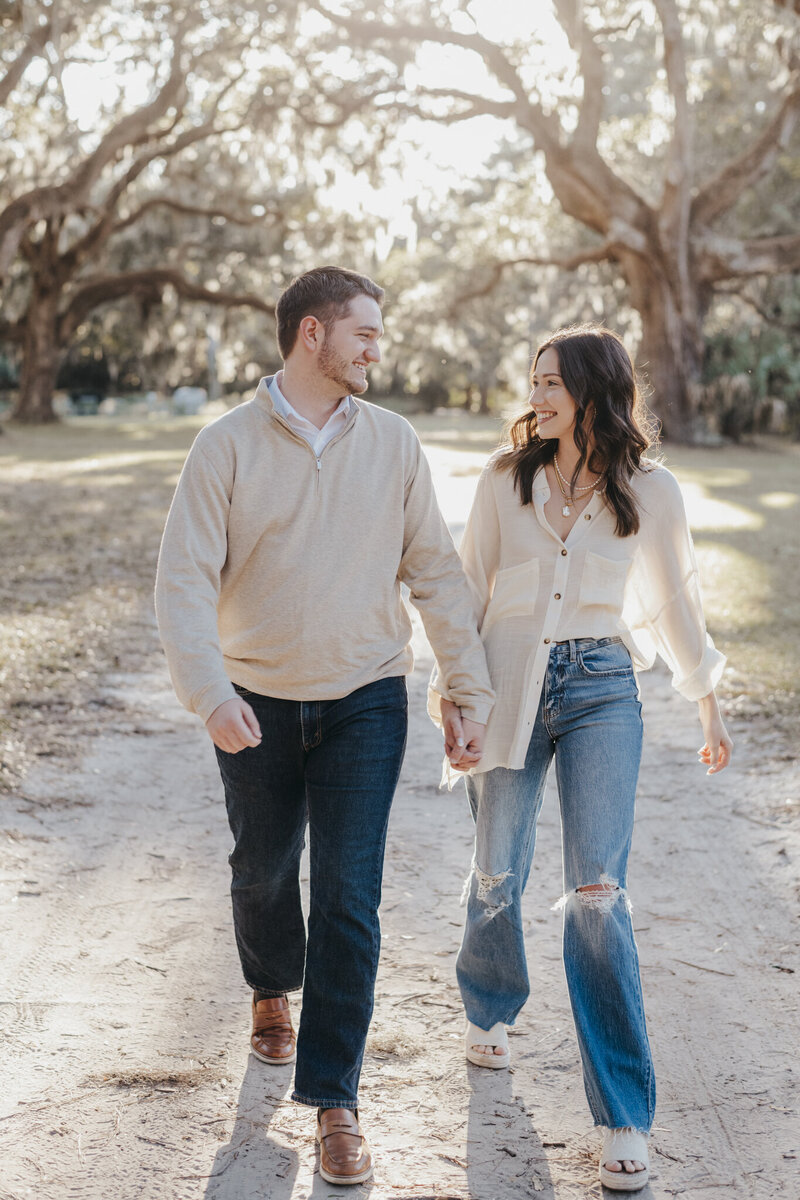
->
[156,266,732,1192]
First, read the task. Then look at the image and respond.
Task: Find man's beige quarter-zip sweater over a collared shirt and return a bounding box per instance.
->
[156,378,494,722]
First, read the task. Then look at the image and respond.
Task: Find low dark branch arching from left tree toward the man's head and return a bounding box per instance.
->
[59,266,275,344]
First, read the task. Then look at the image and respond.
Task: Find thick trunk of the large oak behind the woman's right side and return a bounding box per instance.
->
[624,258,703,442]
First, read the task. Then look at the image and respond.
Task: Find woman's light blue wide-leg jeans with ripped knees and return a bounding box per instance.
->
[456,637,655,1132]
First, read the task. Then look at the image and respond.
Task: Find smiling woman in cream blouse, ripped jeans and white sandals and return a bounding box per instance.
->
[431,325,732,1192]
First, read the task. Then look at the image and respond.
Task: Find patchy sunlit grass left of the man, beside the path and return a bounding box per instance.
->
[0,418,203,790]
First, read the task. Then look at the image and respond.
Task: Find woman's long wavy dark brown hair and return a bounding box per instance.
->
[495,325,656,538]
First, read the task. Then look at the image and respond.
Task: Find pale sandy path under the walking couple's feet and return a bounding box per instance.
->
[0,454,800,1200]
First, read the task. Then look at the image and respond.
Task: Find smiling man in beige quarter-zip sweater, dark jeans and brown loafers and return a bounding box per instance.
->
[156,266,494,1183]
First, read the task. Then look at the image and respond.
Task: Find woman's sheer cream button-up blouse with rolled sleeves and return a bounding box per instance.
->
[428,456,726,772]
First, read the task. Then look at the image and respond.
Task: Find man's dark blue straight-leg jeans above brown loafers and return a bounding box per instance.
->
[217,677,408,1109]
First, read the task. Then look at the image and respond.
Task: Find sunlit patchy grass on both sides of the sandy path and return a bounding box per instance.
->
[0,412,800,790]
